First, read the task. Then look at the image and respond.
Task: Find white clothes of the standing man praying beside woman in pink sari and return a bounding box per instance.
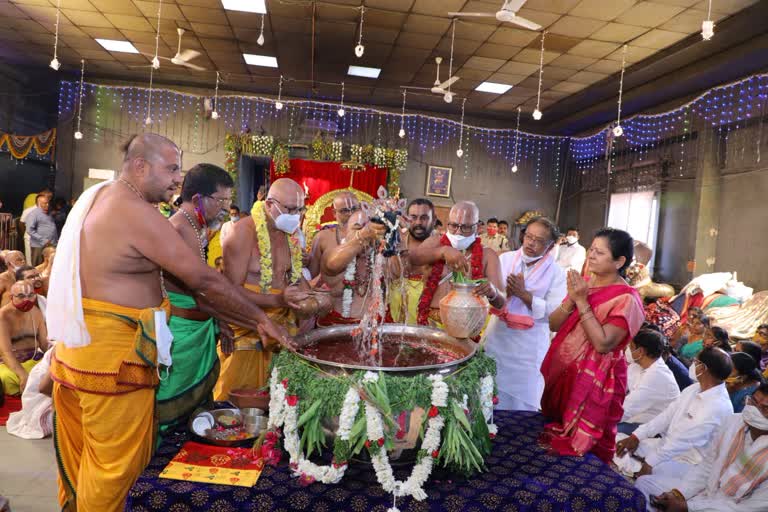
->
[485,249,566,411]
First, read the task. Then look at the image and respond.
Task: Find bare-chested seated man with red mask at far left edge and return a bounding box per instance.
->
[0,281,48,395]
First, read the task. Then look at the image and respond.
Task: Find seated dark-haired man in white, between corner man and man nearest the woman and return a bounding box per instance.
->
[616,347,733,506]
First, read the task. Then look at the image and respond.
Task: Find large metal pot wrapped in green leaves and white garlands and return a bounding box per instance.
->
[268,324,497,504]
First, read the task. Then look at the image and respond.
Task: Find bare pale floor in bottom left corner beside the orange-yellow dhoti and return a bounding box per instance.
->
[0,427,60,512]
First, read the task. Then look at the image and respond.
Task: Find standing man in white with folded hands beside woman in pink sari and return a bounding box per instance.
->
[485,217,566,411]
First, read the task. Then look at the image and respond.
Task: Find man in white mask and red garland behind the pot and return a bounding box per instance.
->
[409,201,505,328]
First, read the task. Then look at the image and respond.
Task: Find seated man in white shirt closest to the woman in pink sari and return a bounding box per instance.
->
[619,329,680,435]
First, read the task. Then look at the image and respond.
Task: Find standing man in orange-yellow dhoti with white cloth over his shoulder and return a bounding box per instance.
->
[46,134,289,512]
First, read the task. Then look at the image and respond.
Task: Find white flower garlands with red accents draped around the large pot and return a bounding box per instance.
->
[268,368,498,506]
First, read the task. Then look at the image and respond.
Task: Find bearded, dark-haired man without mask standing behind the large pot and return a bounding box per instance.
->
[389,197,436,325]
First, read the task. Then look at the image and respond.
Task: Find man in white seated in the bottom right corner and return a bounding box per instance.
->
[651,384,768,512]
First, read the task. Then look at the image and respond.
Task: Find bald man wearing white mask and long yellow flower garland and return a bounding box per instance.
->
[213,178,328,400]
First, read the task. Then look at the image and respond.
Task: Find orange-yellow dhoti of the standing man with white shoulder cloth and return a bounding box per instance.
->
[51,299,168,512]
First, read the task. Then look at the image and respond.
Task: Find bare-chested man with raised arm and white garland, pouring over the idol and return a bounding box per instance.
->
[317,210,386,327]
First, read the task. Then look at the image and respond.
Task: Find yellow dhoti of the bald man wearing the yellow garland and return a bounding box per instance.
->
[213,283,297,400]
